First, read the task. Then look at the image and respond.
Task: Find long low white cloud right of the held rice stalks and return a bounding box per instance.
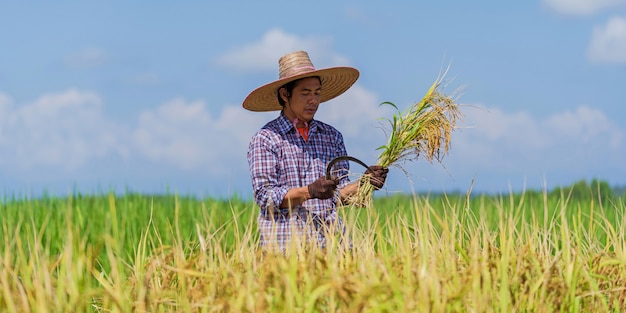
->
[453,106,625,172]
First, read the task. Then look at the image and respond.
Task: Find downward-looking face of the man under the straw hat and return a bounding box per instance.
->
[281,77,322,122]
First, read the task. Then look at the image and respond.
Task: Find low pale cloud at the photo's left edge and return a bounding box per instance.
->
[0,89,127,169]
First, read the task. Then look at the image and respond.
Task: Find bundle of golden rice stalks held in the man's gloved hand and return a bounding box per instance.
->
[332,73,461,207]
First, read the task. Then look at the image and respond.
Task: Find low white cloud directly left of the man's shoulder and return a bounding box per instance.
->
[133,99,264,173]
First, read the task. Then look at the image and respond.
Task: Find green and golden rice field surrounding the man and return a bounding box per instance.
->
[0,179,626,312]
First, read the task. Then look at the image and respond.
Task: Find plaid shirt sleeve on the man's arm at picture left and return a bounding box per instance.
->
[248,131,288,211]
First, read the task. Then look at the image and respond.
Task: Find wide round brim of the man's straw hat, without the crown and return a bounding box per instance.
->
[242,67,359,112]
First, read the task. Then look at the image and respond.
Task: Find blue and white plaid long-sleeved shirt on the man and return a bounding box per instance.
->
[248,113,350,249]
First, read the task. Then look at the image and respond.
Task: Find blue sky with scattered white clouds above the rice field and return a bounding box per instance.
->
[0,0,626,198]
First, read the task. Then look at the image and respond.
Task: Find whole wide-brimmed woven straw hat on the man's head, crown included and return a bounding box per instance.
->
[243,51,359,112]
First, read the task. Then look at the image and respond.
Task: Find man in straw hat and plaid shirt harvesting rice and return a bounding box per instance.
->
[243,51,388,251]
